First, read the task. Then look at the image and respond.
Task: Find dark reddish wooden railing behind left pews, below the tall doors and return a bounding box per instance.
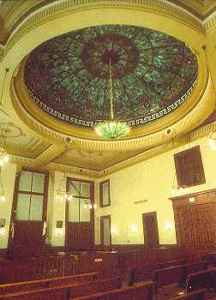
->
[0,252,119,283]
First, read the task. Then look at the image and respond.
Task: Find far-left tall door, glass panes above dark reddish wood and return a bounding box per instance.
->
[9,171,48,257]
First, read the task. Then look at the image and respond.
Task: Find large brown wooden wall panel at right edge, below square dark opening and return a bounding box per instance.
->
[172,191,216,250]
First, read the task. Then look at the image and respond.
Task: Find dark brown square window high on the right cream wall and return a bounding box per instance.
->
[174,146,206,187]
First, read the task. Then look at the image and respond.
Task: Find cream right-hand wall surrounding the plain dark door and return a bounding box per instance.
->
[95,138,216,244]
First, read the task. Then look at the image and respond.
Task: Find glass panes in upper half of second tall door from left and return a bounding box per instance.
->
[68,180,93,223]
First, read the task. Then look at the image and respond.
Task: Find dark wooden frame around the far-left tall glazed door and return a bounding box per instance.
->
[8,168,49,254]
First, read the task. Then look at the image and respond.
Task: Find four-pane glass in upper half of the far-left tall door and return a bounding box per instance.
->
[16,171,46,221]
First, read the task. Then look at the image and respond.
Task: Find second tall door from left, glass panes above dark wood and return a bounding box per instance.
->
[65,178,94,251]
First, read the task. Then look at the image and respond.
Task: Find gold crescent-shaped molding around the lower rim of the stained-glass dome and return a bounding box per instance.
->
[11,41,211,151]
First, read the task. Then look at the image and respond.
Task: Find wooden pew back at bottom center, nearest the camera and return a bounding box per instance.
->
[72,281,154,300]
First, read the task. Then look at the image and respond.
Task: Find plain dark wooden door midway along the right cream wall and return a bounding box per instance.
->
[143,212,159,248]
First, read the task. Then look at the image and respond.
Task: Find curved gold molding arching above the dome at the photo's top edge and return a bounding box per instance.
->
[3,0,204,52]
